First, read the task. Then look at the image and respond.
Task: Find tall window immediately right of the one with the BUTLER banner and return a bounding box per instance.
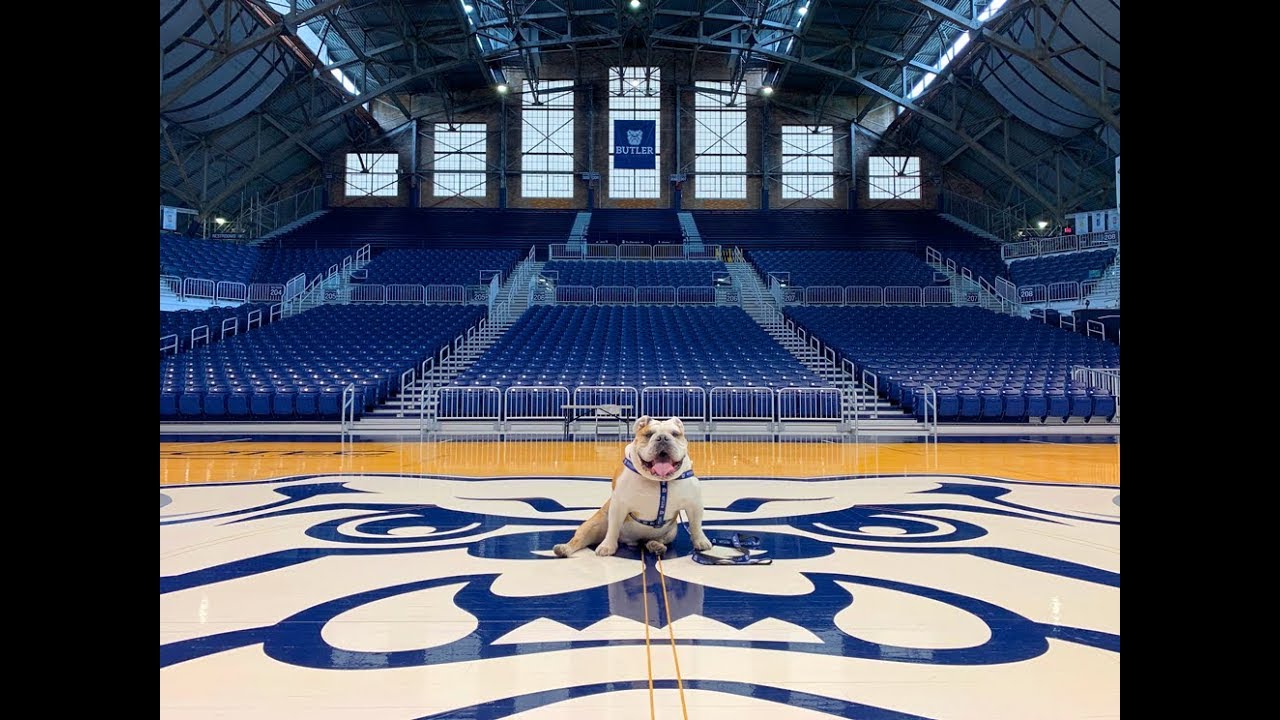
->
[694,82,746,199]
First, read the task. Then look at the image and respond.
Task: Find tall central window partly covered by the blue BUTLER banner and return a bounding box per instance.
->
[609,68,662,197]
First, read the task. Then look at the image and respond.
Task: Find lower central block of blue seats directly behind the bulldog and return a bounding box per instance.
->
[442,305,840,418]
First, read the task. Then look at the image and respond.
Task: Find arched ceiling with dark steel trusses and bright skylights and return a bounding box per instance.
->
[160,0,1120,219]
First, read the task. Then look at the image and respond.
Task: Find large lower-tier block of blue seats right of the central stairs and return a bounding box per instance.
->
[786,307,1120,421]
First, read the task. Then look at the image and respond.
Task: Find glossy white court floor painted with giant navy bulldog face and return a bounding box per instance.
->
[160,474,1120,720]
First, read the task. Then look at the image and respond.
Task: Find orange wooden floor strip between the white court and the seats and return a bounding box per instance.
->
[160,441,1120,487]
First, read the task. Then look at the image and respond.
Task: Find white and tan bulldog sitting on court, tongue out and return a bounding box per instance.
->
[553,415,712,557]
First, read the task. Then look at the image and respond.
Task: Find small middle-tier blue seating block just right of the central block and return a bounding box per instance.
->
[745,250,933,287]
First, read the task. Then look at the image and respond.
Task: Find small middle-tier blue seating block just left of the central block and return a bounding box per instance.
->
[365,249,527,284]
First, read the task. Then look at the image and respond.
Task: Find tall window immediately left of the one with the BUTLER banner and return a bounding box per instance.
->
[520,79,573,197]
